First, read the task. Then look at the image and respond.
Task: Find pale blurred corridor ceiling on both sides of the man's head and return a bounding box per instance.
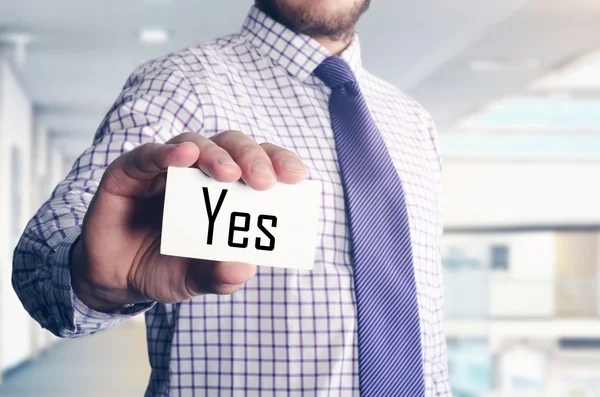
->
[0,0,600,158]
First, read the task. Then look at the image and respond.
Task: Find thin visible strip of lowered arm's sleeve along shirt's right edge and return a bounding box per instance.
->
[423,111,452,397]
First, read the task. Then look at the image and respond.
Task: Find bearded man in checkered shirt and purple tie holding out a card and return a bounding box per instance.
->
[13,0,450,397]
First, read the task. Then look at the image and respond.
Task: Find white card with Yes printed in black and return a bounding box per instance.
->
[160,167,321,269]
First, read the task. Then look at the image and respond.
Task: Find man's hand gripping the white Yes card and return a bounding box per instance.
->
[71,131,306,312]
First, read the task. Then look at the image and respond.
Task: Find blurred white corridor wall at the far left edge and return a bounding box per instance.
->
[0,60,33,369]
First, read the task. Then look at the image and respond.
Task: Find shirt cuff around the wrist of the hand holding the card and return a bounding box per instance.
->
[52,227,155,336]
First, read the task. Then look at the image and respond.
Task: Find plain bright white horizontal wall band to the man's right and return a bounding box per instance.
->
[443,158,600,228]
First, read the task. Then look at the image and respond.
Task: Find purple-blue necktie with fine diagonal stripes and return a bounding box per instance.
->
[314,57,425,397]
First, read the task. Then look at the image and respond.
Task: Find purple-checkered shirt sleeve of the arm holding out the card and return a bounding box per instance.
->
[12,57,202,337]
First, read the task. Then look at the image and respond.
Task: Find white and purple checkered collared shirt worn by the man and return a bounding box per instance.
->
[13,7,451,396]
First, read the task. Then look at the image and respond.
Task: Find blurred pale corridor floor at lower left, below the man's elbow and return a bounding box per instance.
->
[0,321,150,397]
